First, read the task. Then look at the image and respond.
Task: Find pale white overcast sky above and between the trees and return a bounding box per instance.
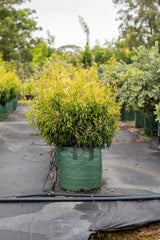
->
[20,0,119,48]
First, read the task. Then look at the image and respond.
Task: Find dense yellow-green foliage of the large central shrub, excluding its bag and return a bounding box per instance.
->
[28,62,119,148]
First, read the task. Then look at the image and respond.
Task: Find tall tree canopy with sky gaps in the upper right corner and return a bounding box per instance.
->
[113,0,160,49]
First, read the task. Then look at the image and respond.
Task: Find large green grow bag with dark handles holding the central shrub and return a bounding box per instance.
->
[56,147,102,191]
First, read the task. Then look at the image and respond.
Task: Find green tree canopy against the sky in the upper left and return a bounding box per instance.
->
[0,6,39,62]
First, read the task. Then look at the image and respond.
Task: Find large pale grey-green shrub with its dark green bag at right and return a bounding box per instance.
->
[118,43,160,134]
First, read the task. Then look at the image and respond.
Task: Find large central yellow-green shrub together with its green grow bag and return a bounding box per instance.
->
[27,62,120,191]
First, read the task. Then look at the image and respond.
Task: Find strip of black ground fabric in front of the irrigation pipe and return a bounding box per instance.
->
[0,200,160,240]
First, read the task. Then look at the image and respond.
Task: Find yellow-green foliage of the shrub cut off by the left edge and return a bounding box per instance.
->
[0,62,20,105]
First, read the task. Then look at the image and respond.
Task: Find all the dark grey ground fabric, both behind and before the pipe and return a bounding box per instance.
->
[0,106,160,240]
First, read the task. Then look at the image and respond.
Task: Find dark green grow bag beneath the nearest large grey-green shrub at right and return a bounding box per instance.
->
[144,114,158,136]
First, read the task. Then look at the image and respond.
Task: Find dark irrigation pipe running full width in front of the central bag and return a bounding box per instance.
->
[0,195,160,203]
